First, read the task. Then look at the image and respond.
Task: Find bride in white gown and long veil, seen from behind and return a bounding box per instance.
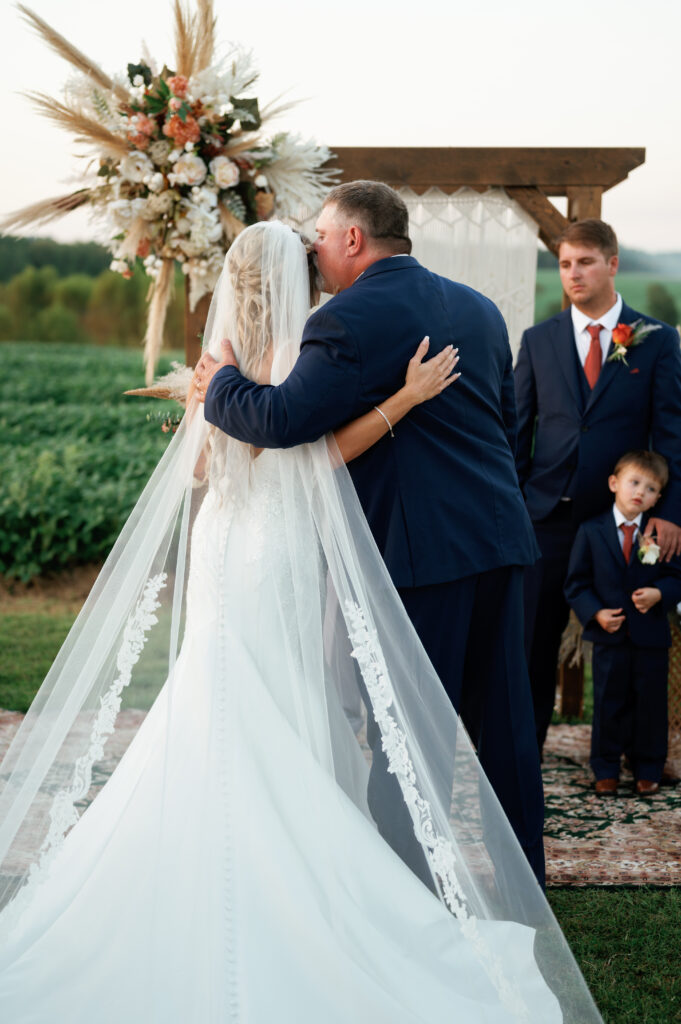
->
[0,222,600,1024]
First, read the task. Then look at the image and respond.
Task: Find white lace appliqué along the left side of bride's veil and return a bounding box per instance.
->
[2,572,167,931]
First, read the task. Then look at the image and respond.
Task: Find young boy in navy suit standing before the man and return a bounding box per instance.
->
[565,452,681,796]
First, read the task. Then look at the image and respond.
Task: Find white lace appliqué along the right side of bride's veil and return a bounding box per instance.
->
[345,599,529,1021]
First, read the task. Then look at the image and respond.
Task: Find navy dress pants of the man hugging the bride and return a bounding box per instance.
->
[399,566,545,885]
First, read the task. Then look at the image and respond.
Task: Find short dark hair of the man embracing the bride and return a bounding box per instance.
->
[324,181,412,255]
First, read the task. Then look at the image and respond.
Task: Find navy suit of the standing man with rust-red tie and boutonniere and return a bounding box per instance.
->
[515,303,681,748]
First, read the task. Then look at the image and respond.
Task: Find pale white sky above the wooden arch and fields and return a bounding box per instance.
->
[0,0,681,251]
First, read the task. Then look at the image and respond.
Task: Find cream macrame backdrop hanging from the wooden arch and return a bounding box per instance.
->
[298,188,538,357]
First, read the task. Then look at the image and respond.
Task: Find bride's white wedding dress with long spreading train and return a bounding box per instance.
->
[0,452,560,1024]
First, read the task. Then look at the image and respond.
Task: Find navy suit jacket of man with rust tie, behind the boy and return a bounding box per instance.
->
[515,304,681,525]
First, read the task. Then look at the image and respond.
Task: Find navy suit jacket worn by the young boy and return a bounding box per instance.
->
[565,508,681,647]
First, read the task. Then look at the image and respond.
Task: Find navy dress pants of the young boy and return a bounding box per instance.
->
[591,641,669,782]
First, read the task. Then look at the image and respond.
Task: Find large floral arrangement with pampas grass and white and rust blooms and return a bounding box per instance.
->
[0,0,337,383]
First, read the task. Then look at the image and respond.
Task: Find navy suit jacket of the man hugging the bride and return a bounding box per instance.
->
[205,256,538,587]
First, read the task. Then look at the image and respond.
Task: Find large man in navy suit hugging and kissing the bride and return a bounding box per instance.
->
[193,181,544,881]
